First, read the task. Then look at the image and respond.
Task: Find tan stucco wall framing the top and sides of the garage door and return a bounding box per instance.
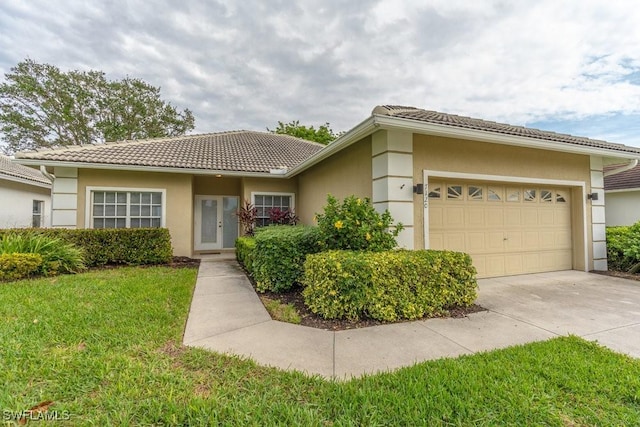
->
[413,134,592,269]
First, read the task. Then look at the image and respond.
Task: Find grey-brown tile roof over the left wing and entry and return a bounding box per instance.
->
[16,131,324,173]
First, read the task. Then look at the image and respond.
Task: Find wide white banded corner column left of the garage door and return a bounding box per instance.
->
[371,130,414,249]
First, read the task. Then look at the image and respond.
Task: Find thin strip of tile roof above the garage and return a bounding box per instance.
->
[372,105,640,154]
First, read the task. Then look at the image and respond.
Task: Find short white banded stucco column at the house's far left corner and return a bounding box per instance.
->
[51,167,78,228]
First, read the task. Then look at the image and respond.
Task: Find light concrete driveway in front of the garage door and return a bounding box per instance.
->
[478,271,640,357]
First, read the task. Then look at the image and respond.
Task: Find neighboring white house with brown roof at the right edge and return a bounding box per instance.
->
[604,165,640,226]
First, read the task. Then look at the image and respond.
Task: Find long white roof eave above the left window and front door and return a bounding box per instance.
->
[15,157,285,178]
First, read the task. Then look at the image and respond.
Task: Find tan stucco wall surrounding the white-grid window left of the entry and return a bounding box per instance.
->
[77,169,193,256]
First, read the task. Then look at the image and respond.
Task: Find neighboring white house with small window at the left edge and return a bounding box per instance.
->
[0,156,51,228]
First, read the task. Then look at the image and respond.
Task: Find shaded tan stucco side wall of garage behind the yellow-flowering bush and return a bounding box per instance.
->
[296,136,372,224]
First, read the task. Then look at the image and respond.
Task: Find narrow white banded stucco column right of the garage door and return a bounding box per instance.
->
[589,156,607,271]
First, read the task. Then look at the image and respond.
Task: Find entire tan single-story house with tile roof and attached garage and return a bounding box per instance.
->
[17,106,640,277]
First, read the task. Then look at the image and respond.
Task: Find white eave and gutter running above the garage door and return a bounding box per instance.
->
[373,114,640,159]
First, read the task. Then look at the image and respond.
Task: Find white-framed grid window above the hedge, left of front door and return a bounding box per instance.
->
[91,191,162,228]
